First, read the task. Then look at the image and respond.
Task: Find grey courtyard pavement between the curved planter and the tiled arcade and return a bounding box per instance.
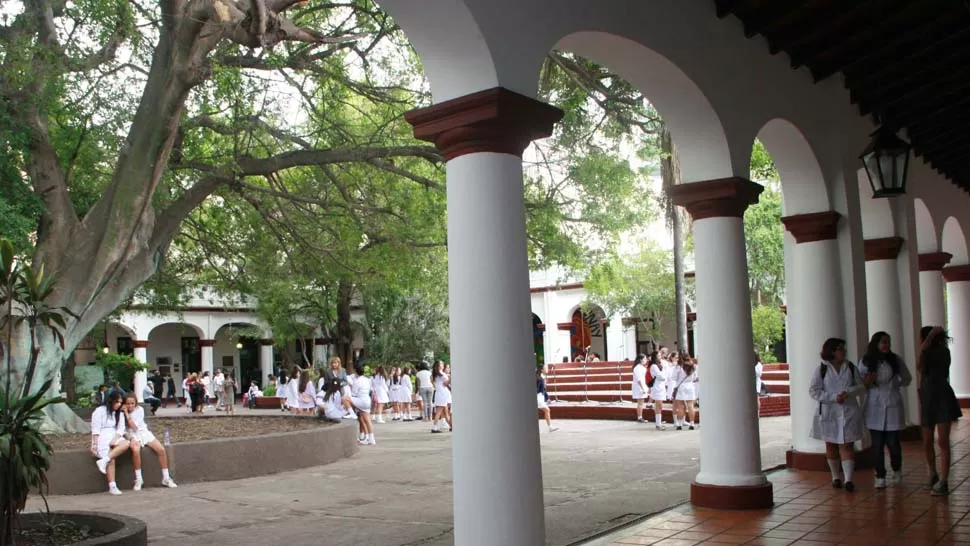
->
[28,409,791,546]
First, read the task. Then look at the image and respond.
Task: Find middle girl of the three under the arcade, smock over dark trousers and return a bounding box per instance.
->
[859,332,913,489]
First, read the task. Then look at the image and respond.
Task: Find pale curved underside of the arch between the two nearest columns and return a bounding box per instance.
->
[548,31,728,182]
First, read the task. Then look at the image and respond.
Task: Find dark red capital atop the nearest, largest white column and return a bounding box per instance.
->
[404,87,563,161]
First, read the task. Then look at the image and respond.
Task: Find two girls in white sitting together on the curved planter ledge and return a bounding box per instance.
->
[91,391,177,495]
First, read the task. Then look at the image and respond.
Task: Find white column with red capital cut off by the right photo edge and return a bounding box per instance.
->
[943,265,970,398]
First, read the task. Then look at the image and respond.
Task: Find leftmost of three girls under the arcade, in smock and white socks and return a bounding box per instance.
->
[809,338,866,493]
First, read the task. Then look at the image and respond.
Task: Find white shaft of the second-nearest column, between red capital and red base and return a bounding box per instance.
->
[694,217,765,486]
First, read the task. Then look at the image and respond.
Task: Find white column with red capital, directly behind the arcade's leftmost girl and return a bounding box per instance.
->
[782,211,845,456]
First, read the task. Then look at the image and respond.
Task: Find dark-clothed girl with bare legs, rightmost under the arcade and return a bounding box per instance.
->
[916,326,961,497]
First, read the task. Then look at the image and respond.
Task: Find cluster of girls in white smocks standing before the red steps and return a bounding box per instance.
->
[631,347,700,430]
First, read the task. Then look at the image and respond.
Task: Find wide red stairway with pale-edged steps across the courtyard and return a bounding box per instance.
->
[546,362,791,422]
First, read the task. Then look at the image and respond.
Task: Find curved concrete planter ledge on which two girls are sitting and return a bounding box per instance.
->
[47,417,360,495]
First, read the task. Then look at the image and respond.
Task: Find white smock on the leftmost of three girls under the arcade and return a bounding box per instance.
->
[808,361,866,444]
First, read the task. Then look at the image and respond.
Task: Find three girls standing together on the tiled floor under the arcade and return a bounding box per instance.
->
[809,326,961,496]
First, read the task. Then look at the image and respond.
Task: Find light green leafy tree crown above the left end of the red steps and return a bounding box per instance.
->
[584,240,676,337]
